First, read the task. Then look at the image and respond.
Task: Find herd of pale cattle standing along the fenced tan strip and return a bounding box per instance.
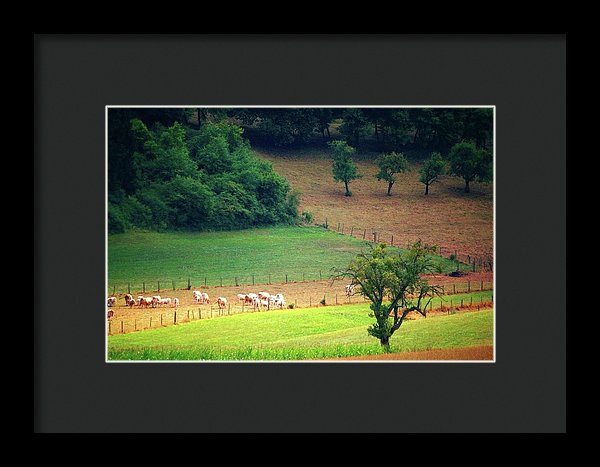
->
[106,284,354,318]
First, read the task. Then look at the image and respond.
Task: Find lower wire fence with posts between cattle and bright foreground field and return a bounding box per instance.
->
[108,281,493,335]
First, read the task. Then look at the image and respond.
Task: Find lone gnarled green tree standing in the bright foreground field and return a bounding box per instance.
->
[336,242,441,352]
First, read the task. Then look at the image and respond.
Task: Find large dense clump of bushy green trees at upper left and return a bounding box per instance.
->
[108,109,299,233]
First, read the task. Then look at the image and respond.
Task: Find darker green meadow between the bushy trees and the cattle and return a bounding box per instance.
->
[108,227,464,292]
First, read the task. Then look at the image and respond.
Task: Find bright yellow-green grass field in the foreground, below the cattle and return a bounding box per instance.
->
[108,295,493,360]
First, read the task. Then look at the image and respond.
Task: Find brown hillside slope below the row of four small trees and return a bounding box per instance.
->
[257,150,493,261]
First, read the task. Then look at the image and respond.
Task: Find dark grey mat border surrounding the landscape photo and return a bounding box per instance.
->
[34,35,566,433]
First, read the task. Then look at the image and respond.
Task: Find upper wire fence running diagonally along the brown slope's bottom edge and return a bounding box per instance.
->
[315,217,494,272]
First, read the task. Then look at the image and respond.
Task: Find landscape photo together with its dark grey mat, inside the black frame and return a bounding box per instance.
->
[34,34,566,433]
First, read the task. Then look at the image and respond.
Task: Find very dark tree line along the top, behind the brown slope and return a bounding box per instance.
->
[225,108,493,155]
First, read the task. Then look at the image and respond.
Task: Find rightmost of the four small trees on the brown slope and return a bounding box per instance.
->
[448,141,493,193]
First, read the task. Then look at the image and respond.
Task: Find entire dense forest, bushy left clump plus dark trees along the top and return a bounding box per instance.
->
[108,108,493,233]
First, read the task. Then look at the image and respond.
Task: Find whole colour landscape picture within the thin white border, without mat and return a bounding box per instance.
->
[106,105,495,364]
